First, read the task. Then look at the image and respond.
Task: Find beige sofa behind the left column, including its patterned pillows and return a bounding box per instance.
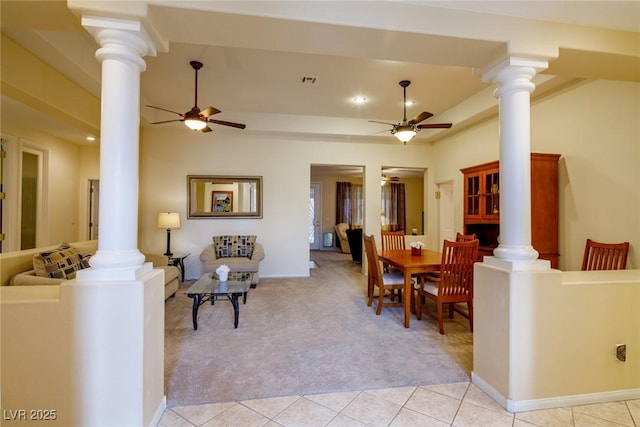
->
[0,240,180,300]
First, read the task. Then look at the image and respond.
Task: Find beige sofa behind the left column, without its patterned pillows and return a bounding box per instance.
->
[0,240,180,300]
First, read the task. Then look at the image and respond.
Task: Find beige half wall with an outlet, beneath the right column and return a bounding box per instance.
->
[473,264,640,411]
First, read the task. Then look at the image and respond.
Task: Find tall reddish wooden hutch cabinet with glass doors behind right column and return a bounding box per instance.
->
[460,153,560,268]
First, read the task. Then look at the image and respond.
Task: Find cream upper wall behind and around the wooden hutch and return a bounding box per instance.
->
[433,81,640,270]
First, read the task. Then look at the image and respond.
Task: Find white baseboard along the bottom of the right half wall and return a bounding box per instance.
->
[471,372,640,413]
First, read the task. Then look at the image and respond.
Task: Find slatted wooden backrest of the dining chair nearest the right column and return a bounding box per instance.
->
[438,239,478,300]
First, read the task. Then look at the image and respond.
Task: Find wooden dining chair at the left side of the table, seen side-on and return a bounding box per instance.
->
[363,235,404,315]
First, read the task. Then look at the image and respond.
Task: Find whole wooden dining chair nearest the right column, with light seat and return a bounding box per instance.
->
[415,239,478,335]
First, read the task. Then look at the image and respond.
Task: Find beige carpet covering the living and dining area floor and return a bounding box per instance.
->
[165,252,473,406]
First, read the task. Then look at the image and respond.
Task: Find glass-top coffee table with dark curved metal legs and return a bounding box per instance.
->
[187,273,255,330]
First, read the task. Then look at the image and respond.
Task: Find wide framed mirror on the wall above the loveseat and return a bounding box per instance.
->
[187,175,262,218]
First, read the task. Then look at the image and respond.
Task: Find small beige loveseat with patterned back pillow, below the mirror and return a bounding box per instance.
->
[200,235,265,288]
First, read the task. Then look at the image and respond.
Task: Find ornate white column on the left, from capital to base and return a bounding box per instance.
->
[78,16,156,280]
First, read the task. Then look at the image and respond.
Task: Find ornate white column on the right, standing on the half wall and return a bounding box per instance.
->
[483,57,548,270]
